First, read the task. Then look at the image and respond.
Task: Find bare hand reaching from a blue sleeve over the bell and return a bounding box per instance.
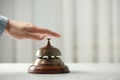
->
[5,20,60,40]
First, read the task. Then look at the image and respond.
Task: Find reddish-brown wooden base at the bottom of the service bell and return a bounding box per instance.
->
[28,65,70,74]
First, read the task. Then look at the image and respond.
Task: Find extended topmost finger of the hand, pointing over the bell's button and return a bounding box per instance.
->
[27,27,61,38]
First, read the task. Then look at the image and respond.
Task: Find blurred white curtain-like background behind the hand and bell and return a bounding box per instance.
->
[0,0,120,63]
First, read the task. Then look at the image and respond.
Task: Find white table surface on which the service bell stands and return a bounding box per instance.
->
[0,63,120,80]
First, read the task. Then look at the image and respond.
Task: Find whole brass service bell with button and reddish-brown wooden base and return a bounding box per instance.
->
[28,38,70,74]
